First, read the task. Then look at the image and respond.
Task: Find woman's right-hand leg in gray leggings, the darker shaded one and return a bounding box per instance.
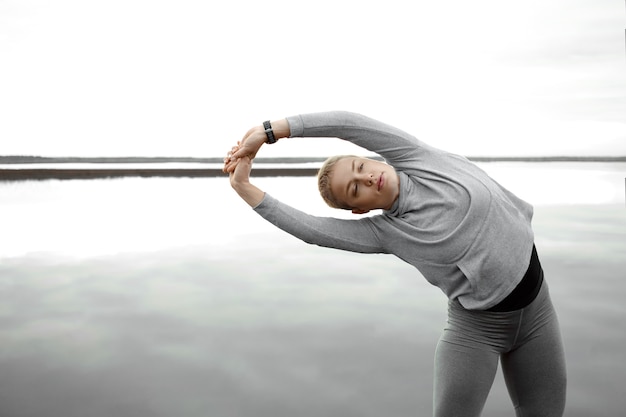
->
[501,288,567,417]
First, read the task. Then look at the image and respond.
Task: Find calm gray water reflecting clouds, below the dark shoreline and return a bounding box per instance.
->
[0,163,626,417]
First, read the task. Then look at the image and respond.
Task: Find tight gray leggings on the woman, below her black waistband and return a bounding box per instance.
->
[434,281,566,417]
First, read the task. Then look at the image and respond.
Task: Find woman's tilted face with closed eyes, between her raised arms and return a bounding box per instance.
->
[330,157,400,214]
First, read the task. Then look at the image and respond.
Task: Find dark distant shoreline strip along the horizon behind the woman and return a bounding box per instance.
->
[0,156,626,181]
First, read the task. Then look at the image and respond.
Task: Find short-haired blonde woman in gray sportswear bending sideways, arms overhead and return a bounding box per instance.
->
[224,112,566,417]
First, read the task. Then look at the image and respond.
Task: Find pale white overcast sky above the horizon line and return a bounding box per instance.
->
[0,0,626,157]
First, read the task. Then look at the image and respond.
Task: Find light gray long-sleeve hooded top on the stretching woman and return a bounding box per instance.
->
[254,112,534,310]
